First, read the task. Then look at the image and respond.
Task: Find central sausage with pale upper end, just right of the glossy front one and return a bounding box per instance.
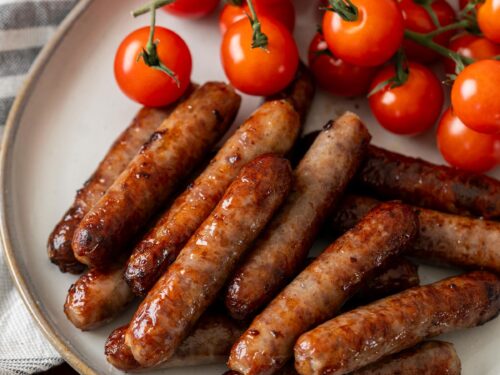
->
[226,112,370,319]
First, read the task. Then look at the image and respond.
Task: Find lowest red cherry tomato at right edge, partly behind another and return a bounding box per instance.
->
[437,109,500,173]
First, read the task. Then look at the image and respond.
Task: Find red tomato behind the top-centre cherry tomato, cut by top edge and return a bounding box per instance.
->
[219,0,295,35]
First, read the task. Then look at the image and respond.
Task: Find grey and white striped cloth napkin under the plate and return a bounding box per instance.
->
[0,0,77,375]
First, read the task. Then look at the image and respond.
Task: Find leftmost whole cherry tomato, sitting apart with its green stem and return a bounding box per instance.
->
[114,26,192,107]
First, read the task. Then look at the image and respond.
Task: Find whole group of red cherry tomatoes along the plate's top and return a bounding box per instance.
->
[115,0,500,172]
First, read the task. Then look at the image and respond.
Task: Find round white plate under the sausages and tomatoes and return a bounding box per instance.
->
[1,0,500,375]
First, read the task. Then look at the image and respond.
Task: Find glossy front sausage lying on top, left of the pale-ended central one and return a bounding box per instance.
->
[125,155,292,367]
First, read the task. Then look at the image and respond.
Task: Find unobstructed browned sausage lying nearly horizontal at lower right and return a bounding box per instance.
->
[295,272,500,375]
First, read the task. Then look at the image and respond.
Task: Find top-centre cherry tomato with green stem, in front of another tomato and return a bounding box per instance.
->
[221,17,299,96]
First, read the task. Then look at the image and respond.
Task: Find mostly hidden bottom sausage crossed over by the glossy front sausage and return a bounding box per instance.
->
[104,311,244,371]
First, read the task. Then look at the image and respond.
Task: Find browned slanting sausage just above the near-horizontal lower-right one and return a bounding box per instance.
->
[228,203,418,375]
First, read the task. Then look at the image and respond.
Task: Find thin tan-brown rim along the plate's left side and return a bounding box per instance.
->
[0,0,97,375]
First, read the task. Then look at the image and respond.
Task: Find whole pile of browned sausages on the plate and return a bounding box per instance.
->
[48,67,500,375]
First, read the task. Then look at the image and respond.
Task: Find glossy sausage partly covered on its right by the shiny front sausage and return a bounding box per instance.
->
[125,100,300,295]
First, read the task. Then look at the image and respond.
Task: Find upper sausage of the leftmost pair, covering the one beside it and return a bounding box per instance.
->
[72,82,241,268]
